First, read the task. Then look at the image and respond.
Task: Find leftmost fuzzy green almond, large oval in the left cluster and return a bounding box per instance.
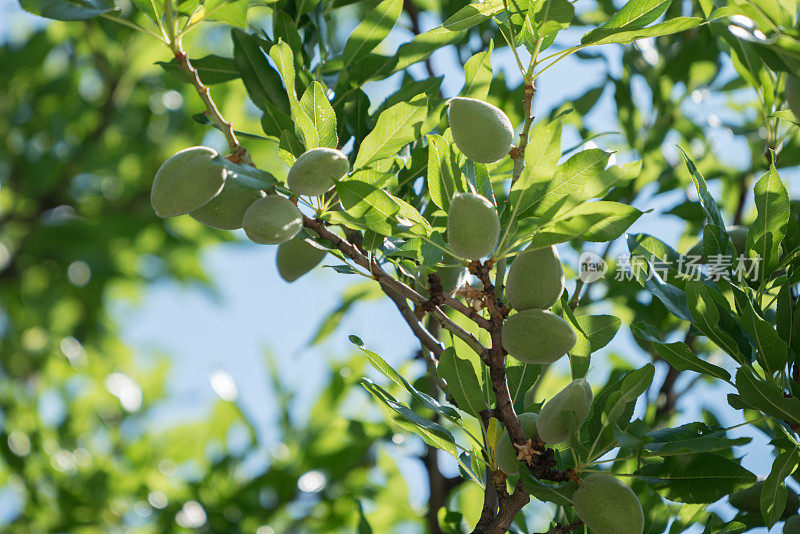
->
[150,146,227,217]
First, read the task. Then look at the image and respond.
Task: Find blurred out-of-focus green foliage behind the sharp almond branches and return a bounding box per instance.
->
[0,0,800,534]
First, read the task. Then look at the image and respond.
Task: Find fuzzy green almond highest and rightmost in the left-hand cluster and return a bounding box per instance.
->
[286,147,350,197]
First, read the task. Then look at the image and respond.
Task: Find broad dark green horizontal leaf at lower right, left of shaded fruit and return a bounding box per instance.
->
[635,453,756,504]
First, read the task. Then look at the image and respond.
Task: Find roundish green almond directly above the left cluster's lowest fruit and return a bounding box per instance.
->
[242,195,303,245]
